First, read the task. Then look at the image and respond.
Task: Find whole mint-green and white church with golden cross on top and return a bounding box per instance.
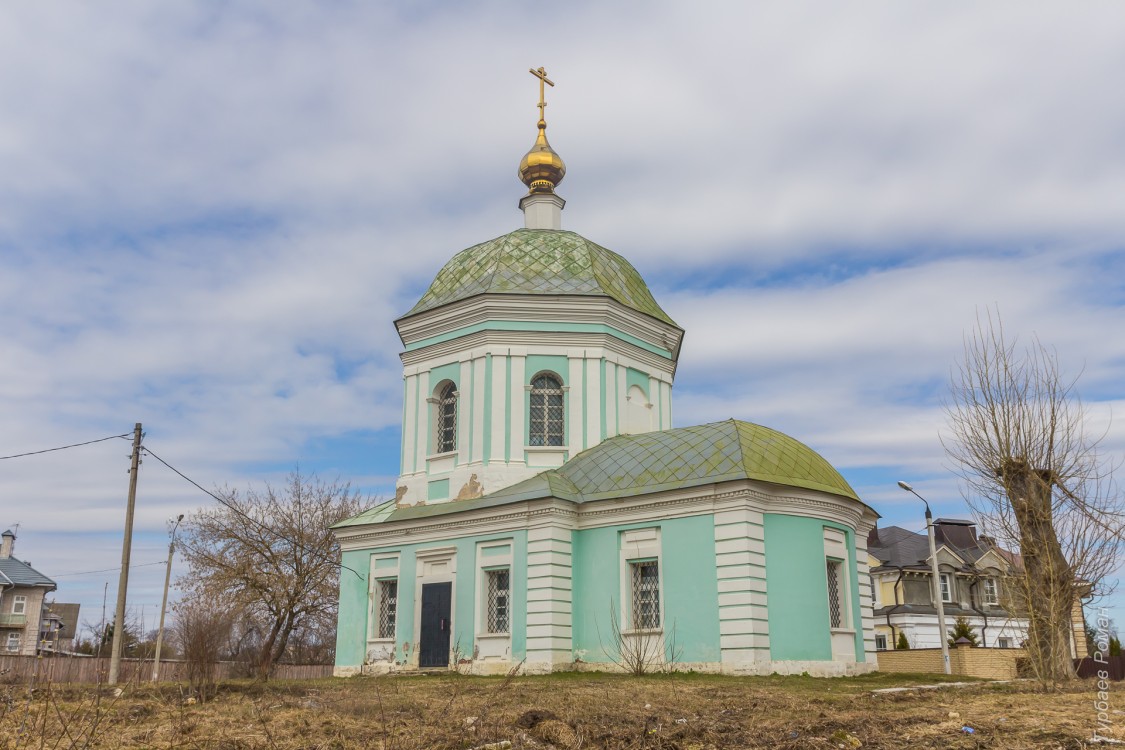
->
[334,69,878,676]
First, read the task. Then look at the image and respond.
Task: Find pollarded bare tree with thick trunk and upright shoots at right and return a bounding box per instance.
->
[943,314,1125,685]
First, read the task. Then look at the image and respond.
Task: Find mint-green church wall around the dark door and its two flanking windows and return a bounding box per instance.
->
[336,531,528,667]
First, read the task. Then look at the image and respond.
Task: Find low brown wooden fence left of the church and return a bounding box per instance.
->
[0,654,332,684]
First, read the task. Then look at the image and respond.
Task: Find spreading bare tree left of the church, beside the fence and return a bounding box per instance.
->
[179,472,365,679]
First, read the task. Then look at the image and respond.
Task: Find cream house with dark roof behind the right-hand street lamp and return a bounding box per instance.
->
[867,518,1086,657]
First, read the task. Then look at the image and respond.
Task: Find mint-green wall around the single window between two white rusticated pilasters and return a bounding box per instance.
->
[572,515,720,663]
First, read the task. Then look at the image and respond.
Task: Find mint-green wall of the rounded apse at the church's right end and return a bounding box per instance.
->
[765,513,864,661]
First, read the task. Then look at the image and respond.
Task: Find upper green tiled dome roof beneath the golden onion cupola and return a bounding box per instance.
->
[406,229,675,325]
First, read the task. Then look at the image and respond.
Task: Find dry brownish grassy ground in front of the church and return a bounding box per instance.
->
[0,674,1125,750]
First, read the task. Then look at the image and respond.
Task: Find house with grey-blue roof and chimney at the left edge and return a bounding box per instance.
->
[0,531,55,656]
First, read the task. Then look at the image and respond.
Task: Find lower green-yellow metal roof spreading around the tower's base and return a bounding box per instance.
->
[338,419,862,526]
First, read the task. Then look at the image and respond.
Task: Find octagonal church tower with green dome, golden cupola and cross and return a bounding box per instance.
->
[395,67,683,506]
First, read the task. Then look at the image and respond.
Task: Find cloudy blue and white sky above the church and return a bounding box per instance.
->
[0,1,1125,638]
